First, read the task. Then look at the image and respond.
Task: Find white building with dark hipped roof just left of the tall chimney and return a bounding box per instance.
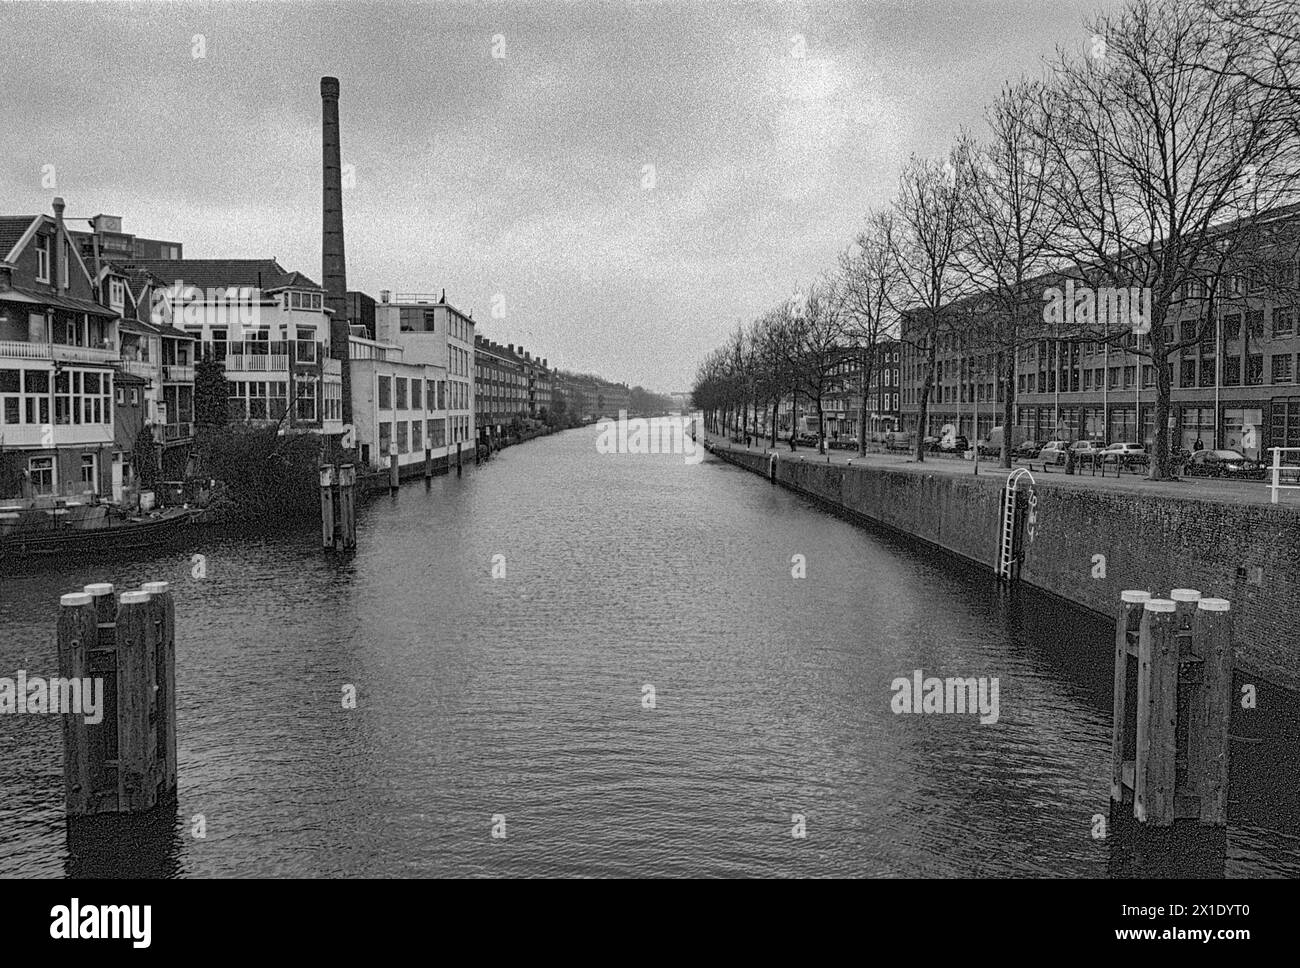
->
[126,259,343,435]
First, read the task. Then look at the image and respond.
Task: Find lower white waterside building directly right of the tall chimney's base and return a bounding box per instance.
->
[348,325,455,470]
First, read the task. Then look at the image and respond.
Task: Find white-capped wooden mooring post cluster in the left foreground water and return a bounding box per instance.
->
[59,582,177,816]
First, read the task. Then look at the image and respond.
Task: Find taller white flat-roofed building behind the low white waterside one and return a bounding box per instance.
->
[374,290,477,452]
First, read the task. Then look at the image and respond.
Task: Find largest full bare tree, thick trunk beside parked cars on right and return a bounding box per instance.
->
[1039,0,1294,479]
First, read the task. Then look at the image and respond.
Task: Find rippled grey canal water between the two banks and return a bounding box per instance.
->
[0,429,1300,877]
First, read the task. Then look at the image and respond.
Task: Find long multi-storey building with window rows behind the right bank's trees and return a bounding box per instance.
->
[901,203,1300,459]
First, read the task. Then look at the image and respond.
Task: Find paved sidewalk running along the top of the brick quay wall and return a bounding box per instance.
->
[705,434,1300,509]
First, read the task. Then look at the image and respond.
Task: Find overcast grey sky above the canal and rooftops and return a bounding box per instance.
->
[0,0,1108,391]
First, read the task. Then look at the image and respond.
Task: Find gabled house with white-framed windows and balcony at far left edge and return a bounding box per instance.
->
[0,197,120,499]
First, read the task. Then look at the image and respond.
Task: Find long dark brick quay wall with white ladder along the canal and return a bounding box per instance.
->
[711,448,1300,693]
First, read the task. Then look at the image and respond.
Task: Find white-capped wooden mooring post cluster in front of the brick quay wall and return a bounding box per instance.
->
[1110,589,1232,826]
